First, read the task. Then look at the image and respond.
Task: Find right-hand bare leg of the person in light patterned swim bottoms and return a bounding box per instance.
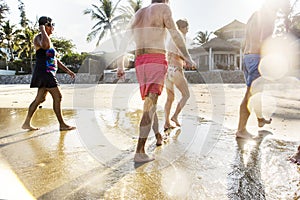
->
[171,70,190,126]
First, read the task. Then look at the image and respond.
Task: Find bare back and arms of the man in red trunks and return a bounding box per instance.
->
[117,0,196,78]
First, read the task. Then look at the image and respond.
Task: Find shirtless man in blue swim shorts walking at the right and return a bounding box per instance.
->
[236,0,286,139]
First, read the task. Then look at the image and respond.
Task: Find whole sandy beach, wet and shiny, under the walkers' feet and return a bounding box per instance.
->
[0,83,300,199]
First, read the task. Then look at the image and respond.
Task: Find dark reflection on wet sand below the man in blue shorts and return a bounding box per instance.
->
[227,131,272,200]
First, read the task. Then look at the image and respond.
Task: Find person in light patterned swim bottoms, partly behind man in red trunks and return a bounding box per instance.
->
[164,19,190,131]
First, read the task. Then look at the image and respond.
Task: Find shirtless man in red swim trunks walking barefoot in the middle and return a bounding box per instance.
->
[117,0,195,163]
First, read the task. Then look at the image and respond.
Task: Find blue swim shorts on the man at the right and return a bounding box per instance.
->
[244,54,260,87]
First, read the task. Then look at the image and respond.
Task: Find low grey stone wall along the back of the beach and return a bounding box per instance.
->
[0,69,245,84]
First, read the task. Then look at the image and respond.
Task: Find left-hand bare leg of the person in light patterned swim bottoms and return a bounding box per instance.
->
[164,78,174,130]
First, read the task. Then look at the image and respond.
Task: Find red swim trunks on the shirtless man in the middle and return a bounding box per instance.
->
[135,53,168,100]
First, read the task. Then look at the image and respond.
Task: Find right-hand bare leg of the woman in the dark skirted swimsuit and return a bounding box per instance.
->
[47,87,75,131]
